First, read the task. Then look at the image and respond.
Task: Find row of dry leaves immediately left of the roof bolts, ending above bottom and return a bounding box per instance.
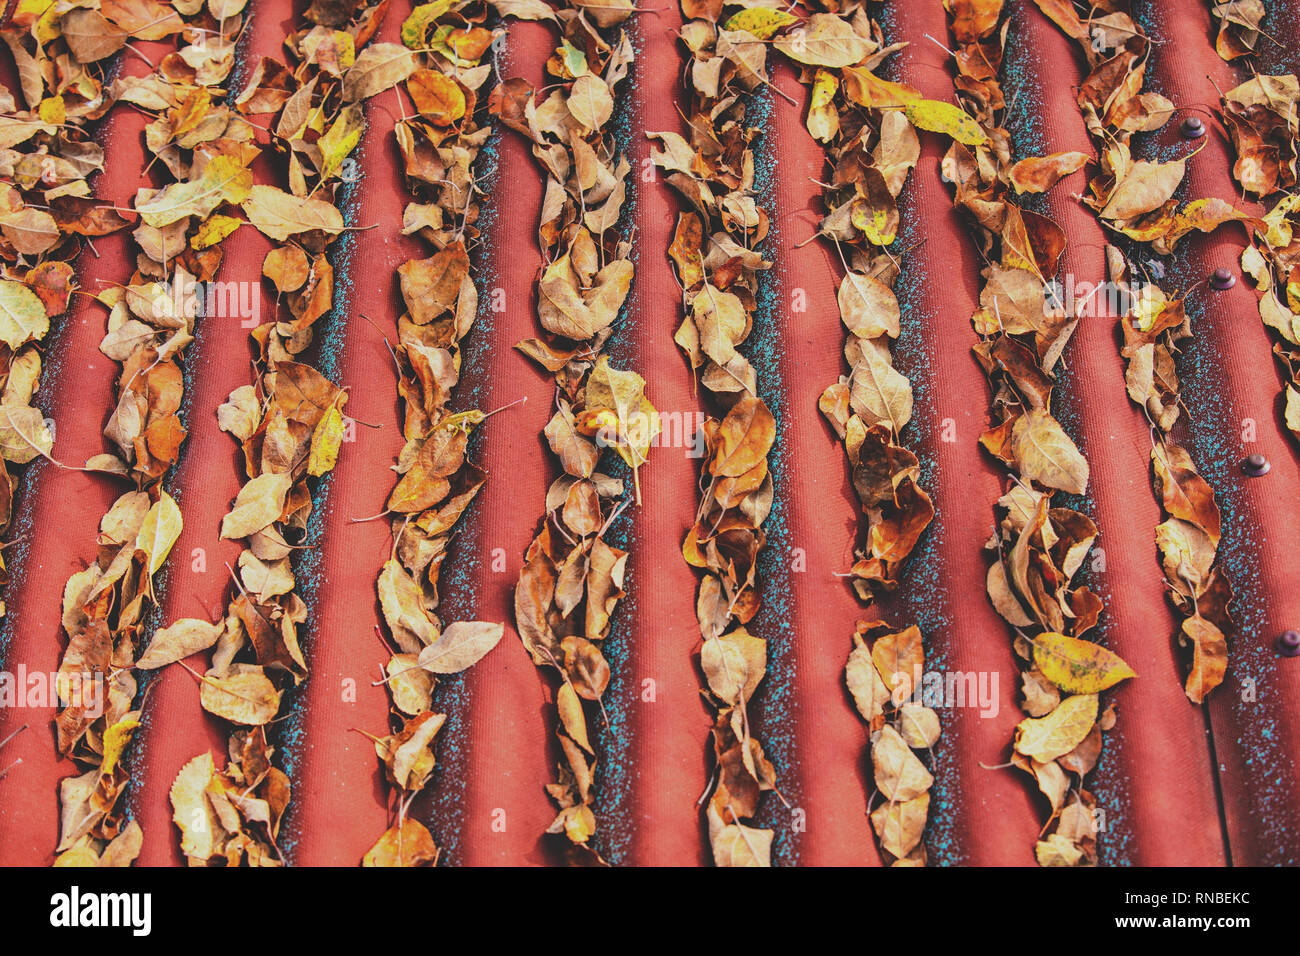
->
[1036,0,1237,704]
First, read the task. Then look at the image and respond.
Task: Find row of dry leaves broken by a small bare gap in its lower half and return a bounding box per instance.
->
[764,4,948,866]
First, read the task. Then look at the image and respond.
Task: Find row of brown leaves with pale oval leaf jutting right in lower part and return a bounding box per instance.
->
[363,0,517,866]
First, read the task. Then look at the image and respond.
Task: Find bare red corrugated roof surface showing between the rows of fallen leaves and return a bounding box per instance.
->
[0,0,1300,865]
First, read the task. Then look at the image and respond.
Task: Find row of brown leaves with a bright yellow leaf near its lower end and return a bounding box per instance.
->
[935,0,1136,866]
